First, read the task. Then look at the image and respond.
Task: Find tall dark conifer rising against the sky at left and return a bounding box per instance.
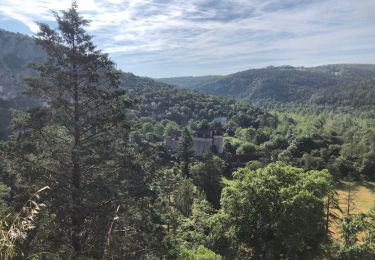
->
[4,2,132,258]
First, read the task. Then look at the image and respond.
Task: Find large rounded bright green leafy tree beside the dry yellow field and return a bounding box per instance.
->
[221,163,331,258]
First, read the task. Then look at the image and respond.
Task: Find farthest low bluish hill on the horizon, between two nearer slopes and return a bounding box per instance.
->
[156,76,224,90]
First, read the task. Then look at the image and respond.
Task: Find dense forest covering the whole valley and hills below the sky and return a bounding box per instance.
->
[0,4,375,260]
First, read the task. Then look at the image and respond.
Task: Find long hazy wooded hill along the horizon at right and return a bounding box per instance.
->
[160,64,375,106]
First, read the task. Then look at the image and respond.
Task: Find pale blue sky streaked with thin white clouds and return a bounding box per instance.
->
[0,0,375,78]
